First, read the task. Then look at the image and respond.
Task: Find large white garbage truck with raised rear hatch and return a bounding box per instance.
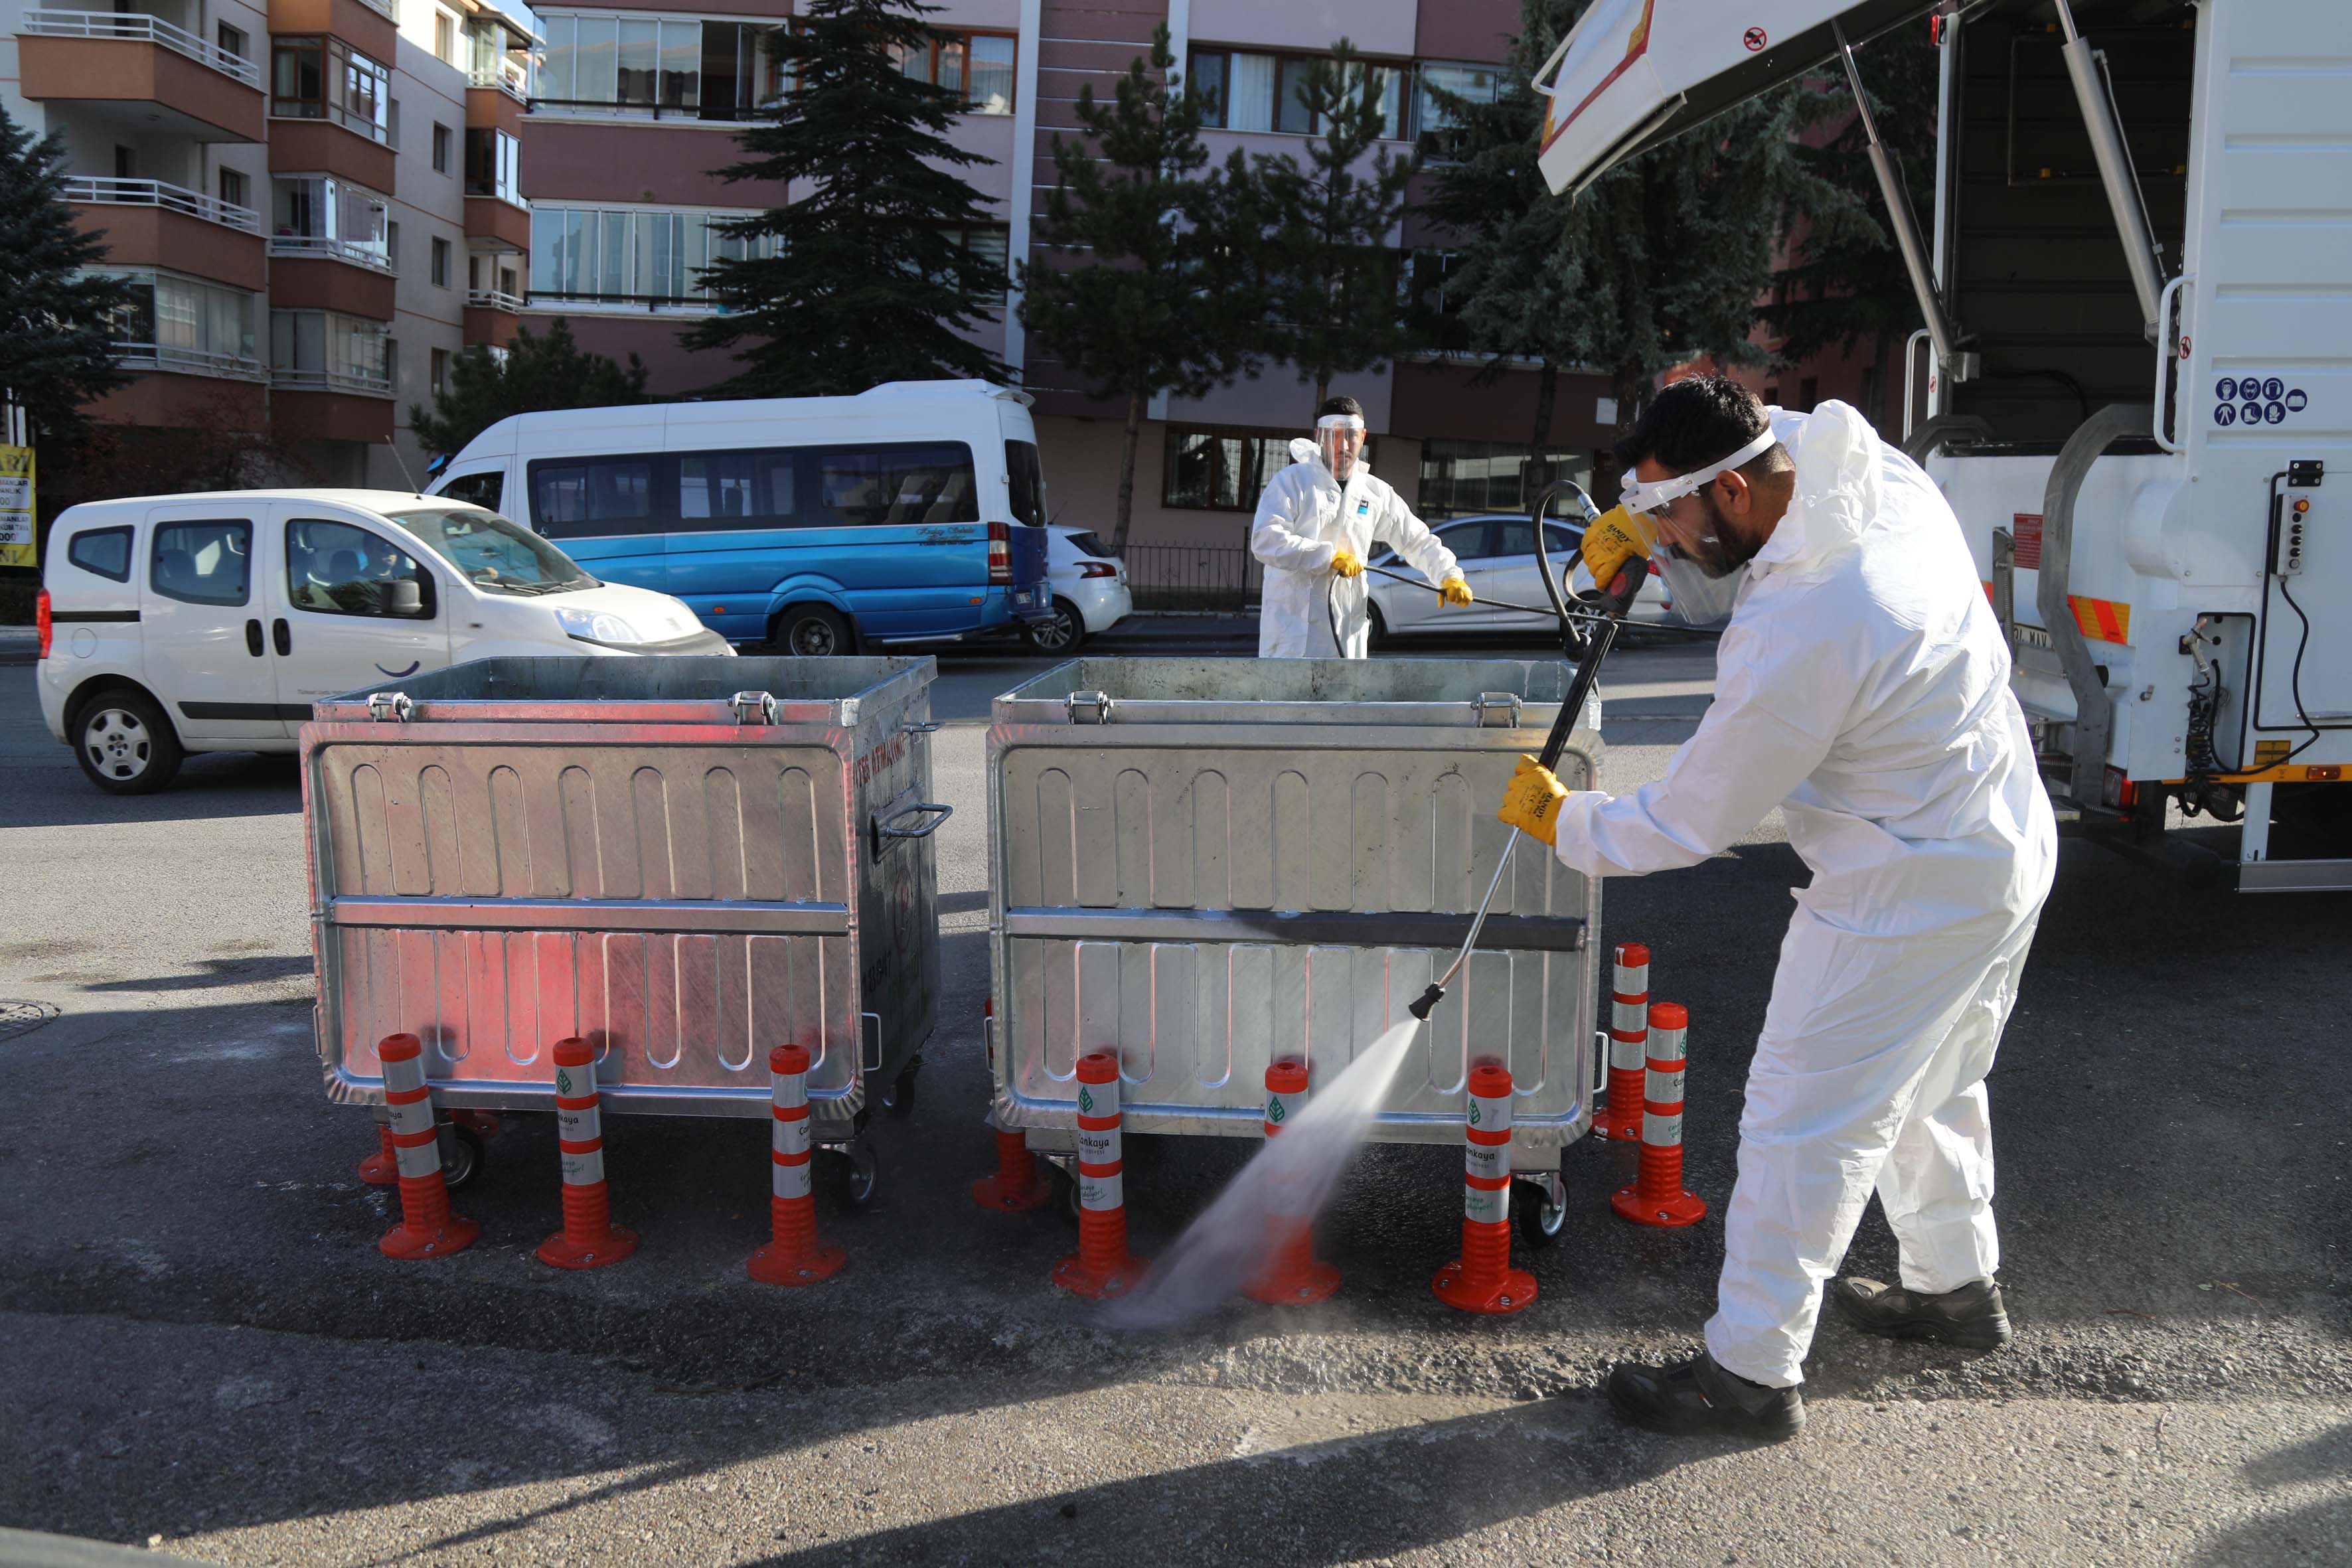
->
[1536,0,2352,891]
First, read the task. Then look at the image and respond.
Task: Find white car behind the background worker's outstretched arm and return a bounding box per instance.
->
[1369,512,1682,642]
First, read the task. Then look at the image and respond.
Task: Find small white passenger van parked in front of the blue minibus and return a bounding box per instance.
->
[40,489,734,795]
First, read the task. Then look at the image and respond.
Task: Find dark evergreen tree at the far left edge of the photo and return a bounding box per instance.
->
[0,108,131,456]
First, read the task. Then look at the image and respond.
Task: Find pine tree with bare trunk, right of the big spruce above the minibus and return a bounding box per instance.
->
[1021,26,1265,555]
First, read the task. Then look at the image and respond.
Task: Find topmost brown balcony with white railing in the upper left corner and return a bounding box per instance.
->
[17,9,266,141]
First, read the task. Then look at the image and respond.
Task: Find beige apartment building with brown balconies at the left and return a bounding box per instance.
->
[0,0,536,487]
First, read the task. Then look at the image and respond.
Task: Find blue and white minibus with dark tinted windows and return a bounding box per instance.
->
[433,381,1054,659]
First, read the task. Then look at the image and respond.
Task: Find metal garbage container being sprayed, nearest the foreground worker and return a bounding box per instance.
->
[988,659,1602,1199]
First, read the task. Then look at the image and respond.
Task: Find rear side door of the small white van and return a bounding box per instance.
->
[134,499,289,747]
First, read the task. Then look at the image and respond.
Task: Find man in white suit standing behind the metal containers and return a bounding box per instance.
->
[1249,397,1470,659]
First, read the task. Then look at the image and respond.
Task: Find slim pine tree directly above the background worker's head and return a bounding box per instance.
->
[1259,38,1416,407]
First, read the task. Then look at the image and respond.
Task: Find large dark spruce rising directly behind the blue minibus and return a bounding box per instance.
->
[684,0,1006,397]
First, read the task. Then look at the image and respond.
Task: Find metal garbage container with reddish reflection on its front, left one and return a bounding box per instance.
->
[301,659,948,1189]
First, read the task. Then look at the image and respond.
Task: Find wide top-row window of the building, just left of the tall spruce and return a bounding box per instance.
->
[532,12,790,120]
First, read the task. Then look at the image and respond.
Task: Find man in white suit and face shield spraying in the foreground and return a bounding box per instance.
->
[1500,378,2058,1439]
